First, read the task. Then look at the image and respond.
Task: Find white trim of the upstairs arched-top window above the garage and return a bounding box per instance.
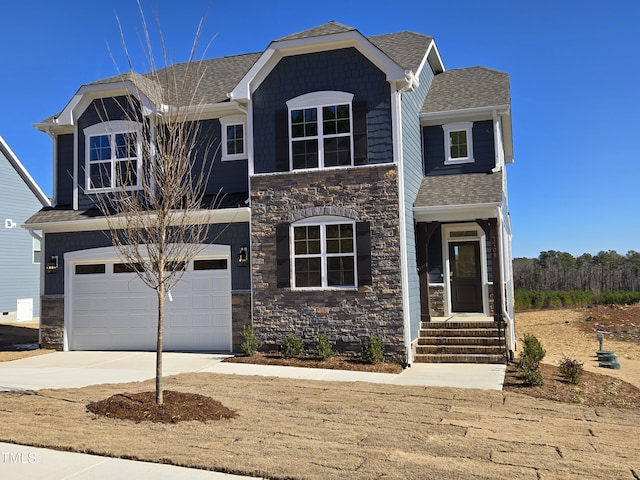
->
[83,120,142,193]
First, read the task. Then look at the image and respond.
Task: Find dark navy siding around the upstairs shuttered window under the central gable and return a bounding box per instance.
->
[253,48,393,173]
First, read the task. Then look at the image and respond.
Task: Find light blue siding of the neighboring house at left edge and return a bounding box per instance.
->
[0,148,42,319]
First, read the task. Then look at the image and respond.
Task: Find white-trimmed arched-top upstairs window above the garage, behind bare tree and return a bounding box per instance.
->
[84,120,142,191]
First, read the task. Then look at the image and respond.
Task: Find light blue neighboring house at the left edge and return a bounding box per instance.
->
[0,137,50,321]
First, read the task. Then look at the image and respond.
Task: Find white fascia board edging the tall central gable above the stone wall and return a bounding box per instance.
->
[230,30,406,102]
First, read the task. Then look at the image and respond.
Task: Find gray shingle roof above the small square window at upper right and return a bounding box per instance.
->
[422,67,511,113]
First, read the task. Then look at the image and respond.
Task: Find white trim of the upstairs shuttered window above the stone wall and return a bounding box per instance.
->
[287,90,354,172]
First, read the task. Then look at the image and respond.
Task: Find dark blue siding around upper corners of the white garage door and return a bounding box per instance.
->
[43,223,251,295]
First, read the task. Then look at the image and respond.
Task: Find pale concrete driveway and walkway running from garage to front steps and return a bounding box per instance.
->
[0,352,505,391]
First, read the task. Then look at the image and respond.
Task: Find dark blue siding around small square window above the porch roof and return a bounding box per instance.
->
[423,120,496,175]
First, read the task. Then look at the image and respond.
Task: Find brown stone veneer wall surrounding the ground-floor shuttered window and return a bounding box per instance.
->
[251,165,406,362]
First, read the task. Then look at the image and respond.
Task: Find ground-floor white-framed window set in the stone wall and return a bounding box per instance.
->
[291,218,357,288]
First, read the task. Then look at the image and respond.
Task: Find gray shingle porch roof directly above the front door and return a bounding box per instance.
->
[414,172,502,207]
